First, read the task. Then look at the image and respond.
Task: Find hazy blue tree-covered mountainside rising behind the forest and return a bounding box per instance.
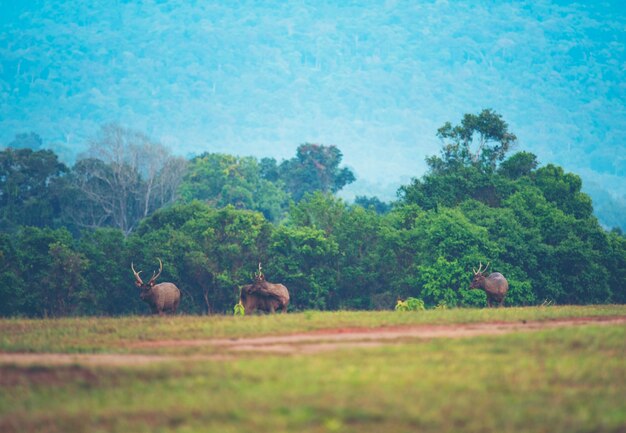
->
[0,0,626,228]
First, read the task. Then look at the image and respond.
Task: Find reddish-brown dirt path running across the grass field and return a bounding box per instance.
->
[0,317,626,366]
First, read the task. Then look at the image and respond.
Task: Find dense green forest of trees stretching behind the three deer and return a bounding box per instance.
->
[0,109,626,317]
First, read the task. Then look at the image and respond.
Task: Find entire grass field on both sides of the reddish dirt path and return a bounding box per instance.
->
[0,306,626,432]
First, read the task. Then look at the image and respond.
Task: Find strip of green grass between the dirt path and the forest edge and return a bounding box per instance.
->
[0,305,626,353]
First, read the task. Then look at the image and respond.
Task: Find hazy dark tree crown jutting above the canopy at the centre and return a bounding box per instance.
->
[276,143,356,201]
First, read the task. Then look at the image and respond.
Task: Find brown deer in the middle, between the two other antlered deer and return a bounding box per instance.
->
[240,263,289,314]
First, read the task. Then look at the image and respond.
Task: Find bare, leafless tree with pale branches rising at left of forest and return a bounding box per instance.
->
[68,124,186,234]
